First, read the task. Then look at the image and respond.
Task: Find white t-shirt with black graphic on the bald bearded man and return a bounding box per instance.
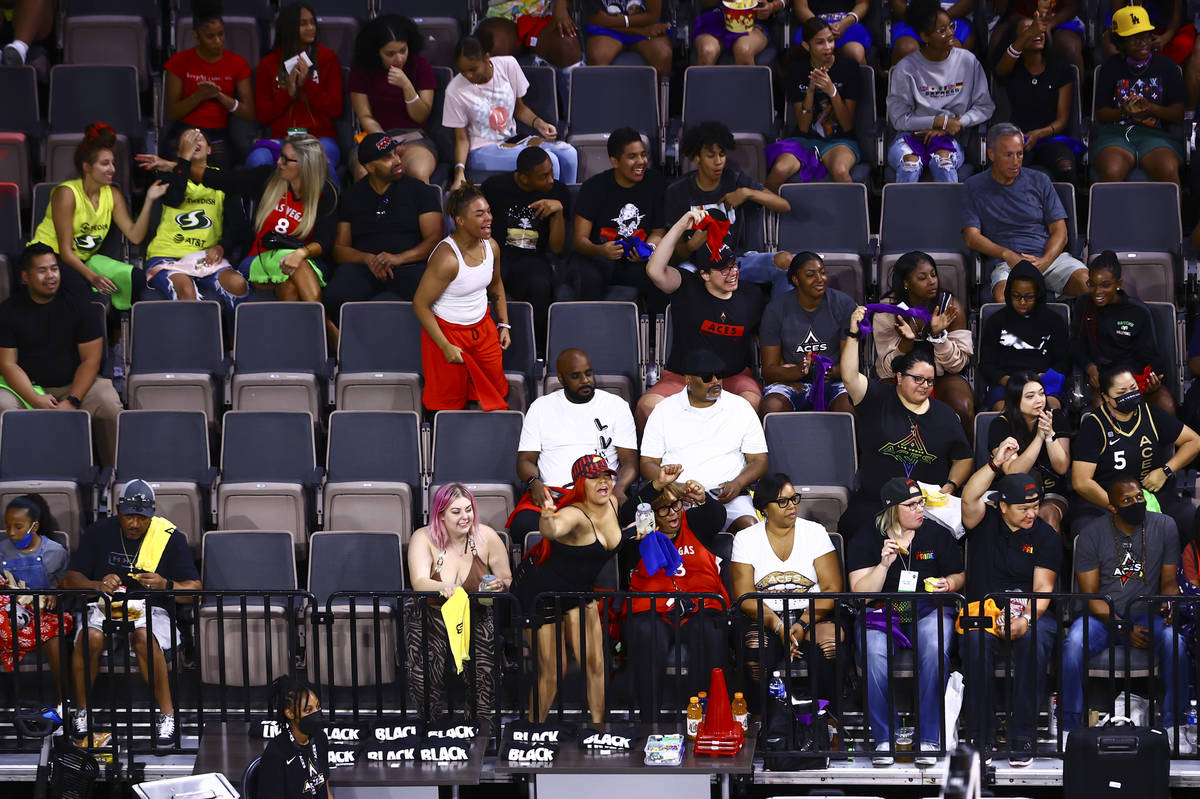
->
[517,389,637,486]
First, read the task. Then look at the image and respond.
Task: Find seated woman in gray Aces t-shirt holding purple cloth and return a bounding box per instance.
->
[758,252,854,416]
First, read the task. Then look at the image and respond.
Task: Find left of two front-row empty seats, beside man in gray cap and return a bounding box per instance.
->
[198,530,304,686]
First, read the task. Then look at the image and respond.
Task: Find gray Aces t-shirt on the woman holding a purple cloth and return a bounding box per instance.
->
[758,288,854,366]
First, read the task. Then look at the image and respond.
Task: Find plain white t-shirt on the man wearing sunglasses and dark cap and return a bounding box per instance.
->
[642,389,767,489]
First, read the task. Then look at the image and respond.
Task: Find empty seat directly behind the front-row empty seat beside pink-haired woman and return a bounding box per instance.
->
[325,410,422,543]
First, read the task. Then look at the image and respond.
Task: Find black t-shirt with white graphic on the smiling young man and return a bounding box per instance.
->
[575,169,666,251]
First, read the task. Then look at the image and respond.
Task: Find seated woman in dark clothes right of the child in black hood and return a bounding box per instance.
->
[1070,250,1175,414]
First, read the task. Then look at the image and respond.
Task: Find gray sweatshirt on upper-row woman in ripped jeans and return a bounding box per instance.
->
[888,47,996,132]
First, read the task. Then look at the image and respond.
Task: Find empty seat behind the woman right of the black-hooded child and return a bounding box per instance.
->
[1087,182,1183,302]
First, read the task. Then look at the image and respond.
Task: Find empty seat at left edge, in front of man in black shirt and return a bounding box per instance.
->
[0,410,100,551]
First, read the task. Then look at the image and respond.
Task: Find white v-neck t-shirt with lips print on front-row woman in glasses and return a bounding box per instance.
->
[731,518,834,613]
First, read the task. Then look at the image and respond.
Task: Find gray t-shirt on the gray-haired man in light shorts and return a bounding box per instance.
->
[962,169,1067,256]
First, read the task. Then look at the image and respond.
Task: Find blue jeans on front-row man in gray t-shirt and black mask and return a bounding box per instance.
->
[1060,614,1189,732]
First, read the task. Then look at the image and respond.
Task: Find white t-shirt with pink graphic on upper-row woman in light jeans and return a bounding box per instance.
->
[442,55,529,150]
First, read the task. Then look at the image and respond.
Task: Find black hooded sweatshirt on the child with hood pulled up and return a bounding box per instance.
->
[979,260,1070,386]
